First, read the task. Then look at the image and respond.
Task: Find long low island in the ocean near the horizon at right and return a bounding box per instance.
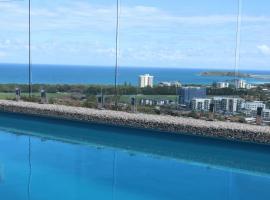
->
[200,71,270,80]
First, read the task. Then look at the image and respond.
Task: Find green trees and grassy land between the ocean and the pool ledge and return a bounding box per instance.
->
[0,84,270,123]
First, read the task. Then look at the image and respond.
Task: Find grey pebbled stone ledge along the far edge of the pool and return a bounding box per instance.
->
[0,100,270,144]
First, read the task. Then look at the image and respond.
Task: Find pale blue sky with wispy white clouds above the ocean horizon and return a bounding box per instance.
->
[0,0,270,70]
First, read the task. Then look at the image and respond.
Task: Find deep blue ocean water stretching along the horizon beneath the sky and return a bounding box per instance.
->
[0,64,270,85]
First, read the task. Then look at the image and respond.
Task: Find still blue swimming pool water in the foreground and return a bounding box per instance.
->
[0,113,270,200]
